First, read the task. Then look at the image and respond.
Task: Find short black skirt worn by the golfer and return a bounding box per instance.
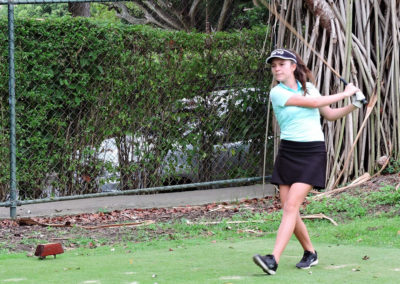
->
[271,140,326,189]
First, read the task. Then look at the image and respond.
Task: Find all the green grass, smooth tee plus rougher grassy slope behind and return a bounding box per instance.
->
[0,182,400,284]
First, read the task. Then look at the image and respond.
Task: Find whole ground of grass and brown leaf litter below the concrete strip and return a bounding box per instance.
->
[0,173,400,283]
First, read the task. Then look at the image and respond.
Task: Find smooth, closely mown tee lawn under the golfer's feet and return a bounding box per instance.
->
[0,238,400,284]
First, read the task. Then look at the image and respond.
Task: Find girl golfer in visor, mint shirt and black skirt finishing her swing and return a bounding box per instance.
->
[253,49,359,274]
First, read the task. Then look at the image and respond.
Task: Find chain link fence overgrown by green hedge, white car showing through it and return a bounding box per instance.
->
[0,1,272,206]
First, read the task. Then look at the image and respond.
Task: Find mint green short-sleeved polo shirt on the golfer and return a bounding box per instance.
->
[270,81,325,142]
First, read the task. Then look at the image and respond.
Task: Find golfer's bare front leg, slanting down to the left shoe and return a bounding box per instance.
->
[272,183,312,262]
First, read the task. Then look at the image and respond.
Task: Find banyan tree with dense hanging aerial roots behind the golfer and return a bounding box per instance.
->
[255,0,400,190]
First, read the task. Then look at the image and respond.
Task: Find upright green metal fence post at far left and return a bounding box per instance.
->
[8,4,17,218]
